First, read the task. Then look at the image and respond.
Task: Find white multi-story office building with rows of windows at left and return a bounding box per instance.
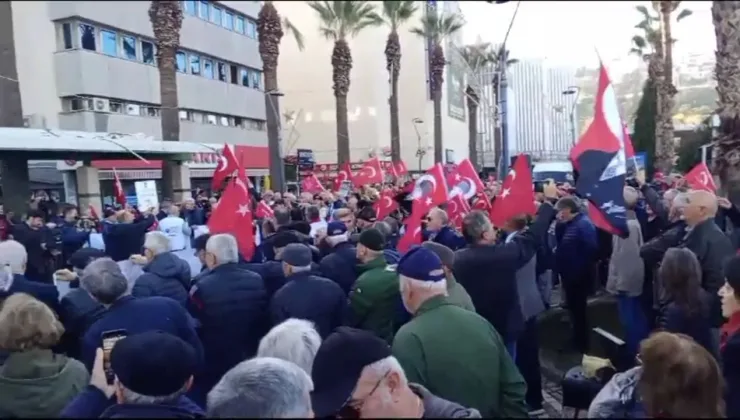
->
[12,0,269,191]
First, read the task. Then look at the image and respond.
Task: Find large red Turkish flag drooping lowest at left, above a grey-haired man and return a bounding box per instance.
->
[208,148,255,260]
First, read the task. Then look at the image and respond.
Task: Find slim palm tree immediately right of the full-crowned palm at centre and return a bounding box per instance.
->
[383,0,417,162]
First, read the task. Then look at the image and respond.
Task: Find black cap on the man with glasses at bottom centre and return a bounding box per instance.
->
[311,327,391,417]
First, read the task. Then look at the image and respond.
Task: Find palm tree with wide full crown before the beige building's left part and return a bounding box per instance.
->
[308,0,383,164]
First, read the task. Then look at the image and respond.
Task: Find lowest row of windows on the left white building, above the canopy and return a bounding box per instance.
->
[62,96,266,131]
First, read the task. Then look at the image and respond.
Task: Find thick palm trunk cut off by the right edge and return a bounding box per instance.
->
[712,0,740,203]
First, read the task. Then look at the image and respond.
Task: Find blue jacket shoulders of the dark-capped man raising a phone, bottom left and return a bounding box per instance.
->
[59,385,205,419]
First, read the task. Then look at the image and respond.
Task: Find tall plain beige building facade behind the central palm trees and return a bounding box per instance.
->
[275,2,468,171]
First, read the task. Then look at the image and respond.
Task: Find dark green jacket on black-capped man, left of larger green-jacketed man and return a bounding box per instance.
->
[349,255,401,344]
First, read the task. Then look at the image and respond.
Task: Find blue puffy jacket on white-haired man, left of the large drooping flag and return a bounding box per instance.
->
[131,252,190,307]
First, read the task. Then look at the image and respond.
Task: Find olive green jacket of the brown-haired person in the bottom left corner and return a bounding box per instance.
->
[0,350,90,418]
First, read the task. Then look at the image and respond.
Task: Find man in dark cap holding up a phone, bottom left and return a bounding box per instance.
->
[60,331,204,418]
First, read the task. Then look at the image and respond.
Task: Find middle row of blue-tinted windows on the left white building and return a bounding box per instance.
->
[61,22,262,89]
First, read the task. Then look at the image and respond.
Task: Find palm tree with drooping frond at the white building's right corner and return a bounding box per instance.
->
[257,1,304,191]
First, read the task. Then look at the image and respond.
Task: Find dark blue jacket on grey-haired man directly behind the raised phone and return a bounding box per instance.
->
[81,296,203,370]
